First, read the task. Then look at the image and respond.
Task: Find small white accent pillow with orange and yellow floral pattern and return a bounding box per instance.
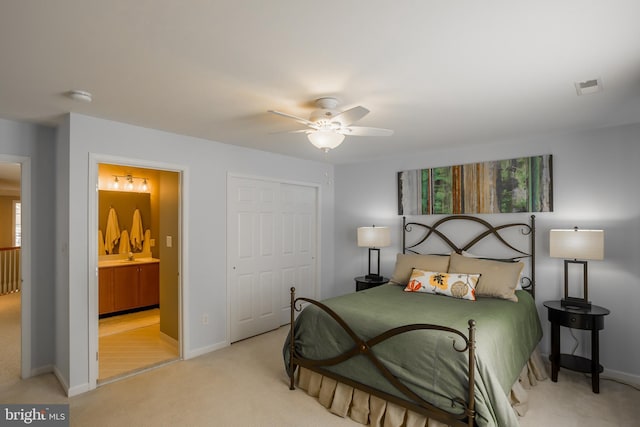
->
[404,268,480,301]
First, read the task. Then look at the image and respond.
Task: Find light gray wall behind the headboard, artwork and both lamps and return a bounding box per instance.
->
[335,125,640,383]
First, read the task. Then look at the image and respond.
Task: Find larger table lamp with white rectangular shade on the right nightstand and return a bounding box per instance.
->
[549,227,604,309]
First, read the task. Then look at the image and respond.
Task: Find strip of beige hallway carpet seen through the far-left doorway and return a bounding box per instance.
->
[0,292,22,385]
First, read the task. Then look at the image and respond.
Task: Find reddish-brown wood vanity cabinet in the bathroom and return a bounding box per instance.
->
[98,262,160,314]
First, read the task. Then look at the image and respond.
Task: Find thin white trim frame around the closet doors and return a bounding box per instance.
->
[225,172,322,346]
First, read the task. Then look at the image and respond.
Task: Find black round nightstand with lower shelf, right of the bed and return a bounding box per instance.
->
[544,301,610,393]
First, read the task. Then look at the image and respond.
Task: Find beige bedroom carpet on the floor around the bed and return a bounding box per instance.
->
[0,328,640,427]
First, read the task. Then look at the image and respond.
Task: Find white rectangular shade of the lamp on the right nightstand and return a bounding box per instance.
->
[549,231,604,260]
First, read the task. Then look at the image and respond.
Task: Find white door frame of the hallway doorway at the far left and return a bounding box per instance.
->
[0,154,31,379]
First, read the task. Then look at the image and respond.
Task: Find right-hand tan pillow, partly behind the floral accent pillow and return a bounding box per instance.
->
[449,254,524,302]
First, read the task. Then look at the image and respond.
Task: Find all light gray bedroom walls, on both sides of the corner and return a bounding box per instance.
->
[0,114,640,394]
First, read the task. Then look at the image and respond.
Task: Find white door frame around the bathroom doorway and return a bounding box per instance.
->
[87,153,189,390]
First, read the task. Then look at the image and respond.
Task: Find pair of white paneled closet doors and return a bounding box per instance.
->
[227,176,317,342]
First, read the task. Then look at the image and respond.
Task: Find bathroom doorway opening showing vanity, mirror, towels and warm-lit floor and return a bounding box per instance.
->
[96,163,181,384]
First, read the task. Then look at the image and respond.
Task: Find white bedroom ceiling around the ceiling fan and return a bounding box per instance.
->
[0,0,640,163]
